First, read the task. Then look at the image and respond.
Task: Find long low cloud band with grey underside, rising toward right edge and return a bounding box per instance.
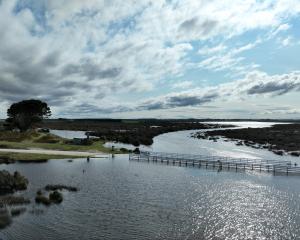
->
[113,71,300,111]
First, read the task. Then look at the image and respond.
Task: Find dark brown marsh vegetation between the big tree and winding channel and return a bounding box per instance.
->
[40,119,229,146]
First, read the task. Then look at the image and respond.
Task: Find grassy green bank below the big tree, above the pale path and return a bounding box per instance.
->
[0,131,125,154]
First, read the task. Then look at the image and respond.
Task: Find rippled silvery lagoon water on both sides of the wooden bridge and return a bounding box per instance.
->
[0,123,300,239]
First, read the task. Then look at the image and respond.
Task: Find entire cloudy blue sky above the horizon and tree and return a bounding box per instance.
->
[0,0,300,118]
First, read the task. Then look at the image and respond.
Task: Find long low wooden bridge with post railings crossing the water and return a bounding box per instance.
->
[129,152,300,175]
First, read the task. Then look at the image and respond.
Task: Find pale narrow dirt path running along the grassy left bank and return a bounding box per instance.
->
[0,148,107,157]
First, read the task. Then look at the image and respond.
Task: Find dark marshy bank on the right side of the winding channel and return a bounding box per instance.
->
[193,124,300,157]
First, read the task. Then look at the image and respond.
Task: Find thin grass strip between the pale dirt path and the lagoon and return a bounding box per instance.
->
[0,152,83,161]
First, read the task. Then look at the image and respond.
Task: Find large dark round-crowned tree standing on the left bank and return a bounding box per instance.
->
[6,99,51,131]
